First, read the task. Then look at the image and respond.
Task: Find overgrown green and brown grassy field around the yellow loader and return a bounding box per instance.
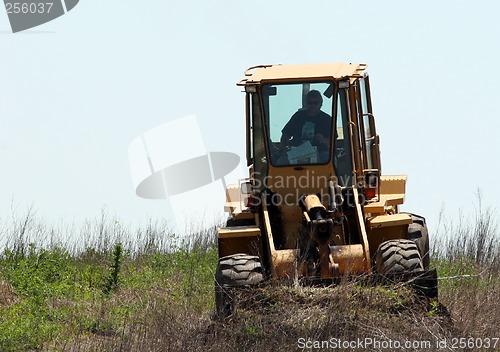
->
[0,207,500,352]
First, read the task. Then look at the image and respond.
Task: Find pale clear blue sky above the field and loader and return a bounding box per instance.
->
[0,0,500,238]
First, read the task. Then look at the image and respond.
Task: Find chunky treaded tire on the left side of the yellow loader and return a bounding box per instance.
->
[215,253,264,319]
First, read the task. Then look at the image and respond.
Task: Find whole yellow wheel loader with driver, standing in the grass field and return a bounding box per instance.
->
[216,63,435,316]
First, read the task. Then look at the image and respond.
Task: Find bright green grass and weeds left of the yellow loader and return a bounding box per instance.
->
[0,213,217,351]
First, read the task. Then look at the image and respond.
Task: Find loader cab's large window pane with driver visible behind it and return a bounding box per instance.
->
[262,82,334,166]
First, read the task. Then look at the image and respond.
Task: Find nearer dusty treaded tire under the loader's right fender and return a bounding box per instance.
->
[375,240,424,276]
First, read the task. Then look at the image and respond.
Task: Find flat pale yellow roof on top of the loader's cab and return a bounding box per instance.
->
[238,62,368,85]
